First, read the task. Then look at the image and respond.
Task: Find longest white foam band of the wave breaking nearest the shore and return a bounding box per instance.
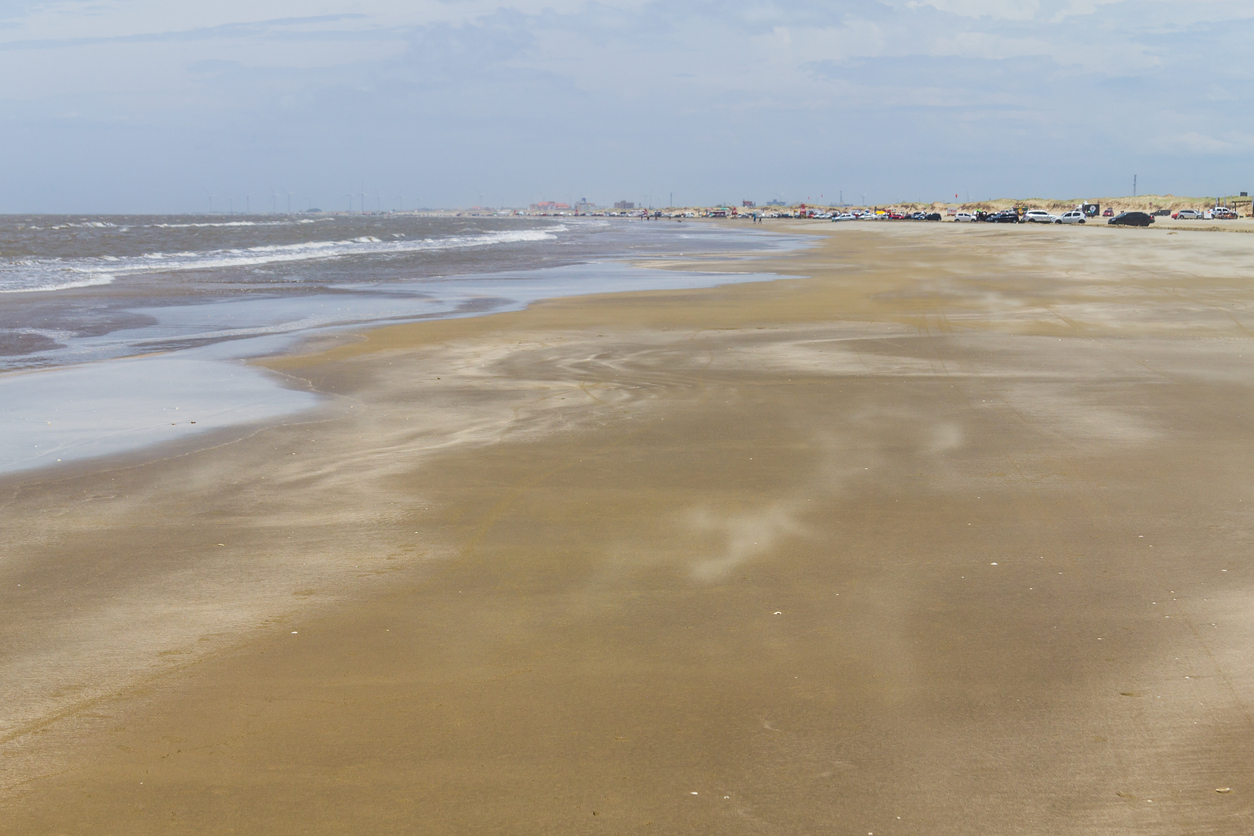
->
[0,226,566,293]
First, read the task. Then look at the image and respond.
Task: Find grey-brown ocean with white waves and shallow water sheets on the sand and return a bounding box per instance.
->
[0,214,801,474]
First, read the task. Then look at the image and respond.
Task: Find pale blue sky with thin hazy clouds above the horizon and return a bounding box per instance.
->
[0,0,1254,213]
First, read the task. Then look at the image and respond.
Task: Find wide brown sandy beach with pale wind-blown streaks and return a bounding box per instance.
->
[0,224,1254,836]
